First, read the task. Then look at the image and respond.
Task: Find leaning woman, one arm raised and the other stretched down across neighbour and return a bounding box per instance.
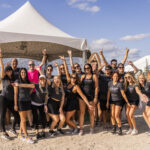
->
[60,56,94,134]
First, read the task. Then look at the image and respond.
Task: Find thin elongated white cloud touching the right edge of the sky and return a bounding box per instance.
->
[120,33,150,41]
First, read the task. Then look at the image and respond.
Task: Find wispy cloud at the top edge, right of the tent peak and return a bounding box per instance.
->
[67,0,100,13]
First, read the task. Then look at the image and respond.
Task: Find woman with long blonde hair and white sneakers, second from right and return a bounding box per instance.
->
[124,73,145,135]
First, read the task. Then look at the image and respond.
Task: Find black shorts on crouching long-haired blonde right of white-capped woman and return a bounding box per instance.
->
[47,99,60,115]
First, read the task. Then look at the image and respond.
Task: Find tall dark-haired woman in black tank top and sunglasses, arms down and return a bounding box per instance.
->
[80,64,98,135]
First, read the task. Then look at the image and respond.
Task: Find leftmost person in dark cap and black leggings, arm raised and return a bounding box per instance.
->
[0,48,19,139]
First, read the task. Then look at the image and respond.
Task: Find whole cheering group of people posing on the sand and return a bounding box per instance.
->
[0,49,150,143]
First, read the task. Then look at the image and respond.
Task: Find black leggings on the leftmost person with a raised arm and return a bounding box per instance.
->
[0,95,20,132]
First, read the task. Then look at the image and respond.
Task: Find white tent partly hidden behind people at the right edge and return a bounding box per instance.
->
[125,55,150,72]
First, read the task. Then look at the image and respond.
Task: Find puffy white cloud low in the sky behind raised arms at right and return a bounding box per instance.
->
[90,38,140,61]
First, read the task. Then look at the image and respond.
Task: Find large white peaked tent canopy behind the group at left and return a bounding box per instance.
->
[0,2,87,60]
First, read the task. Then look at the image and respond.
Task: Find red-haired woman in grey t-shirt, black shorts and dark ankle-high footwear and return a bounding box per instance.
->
[107,72,130,135]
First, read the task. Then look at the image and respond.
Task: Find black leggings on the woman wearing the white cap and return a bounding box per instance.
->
[32,105,46,129]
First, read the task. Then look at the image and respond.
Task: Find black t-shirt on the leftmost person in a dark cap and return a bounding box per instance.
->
[2,76,14,100]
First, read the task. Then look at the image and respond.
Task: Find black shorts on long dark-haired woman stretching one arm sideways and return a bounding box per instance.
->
[18,101,31,111]
